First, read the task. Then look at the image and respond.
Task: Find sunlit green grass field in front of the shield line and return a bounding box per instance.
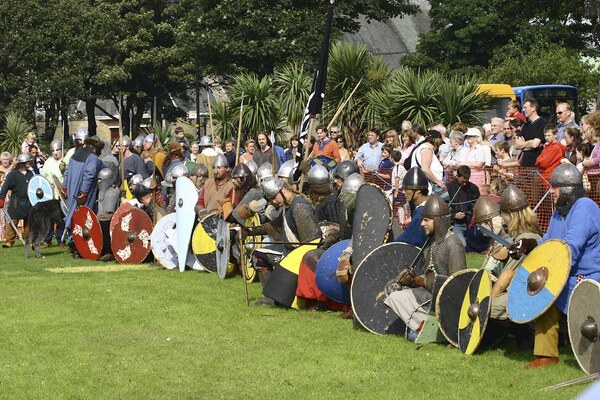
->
[0,246,585,400]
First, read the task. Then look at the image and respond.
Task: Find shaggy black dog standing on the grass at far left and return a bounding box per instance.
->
[25,200,64,258]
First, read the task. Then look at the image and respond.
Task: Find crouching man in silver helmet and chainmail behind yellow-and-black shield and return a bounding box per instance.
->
[242,176,321,304]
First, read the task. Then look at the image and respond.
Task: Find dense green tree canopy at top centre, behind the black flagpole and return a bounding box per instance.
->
[173,0,417,75]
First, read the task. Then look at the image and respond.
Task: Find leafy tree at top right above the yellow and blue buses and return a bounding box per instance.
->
[401,0,597,72]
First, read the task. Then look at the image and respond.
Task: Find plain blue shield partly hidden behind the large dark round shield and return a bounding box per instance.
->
[315,239,350,305]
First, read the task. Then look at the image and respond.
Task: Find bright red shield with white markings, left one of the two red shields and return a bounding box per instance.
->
[71,206,102,260]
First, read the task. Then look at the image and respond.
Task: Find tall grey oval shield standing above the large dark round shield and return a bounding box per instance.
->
[352,183,392,267]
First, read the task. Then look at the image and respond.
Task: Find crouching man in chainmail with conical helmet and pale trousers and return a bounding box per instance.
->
[385,195,467,341]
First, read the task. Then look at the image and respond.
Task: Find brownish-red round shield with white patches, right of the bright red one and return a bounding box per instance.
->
[110,207,152,264]
